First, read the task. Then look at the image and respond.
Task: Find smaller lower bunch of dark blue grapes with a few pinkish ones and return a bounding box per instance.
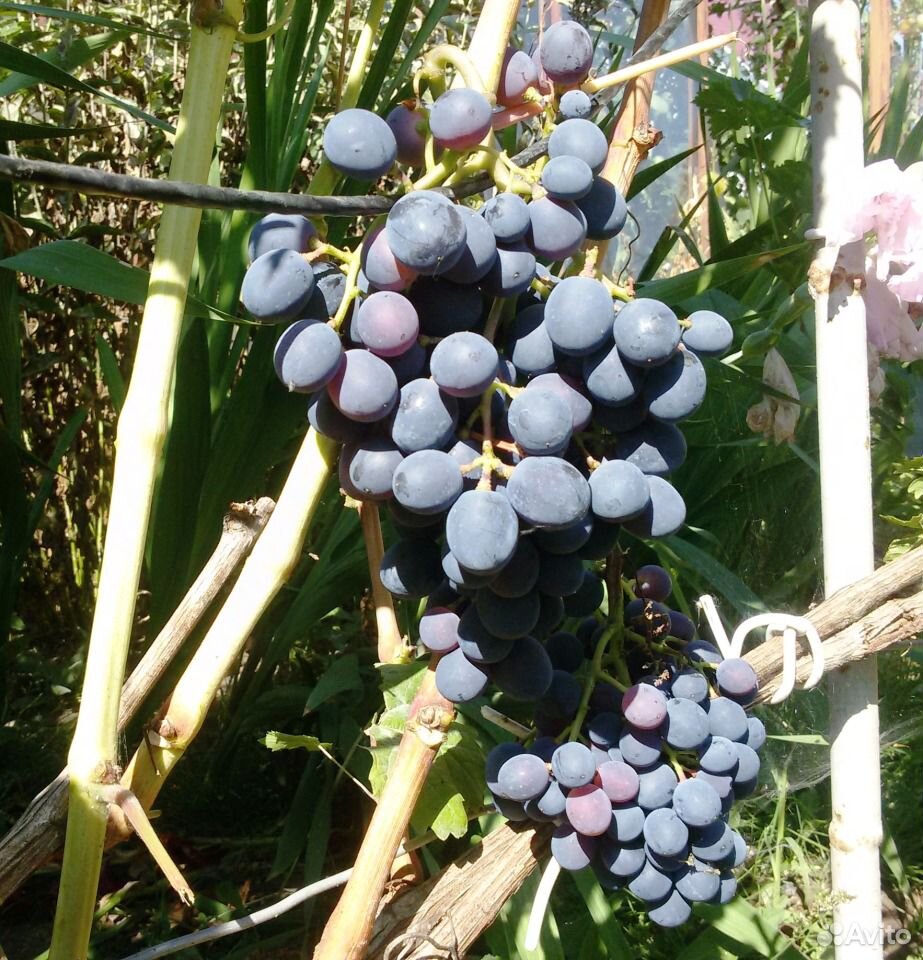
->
[485,566,766,927]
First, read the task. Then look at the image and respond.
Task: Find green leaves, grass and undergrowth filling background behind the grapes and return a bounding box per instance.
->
[0,0,923,960]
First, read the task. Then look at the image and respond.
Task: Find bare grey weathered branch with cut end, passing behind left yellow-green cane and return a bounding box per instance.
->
[0,497,273,903]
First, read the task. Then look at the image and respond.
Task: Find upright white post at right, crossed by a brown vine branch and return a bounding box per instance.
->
[810,0,882,960]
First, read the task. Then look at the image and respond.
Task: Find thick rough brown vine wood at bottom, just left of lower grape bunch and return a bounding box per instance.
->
[368,824,551,960]
